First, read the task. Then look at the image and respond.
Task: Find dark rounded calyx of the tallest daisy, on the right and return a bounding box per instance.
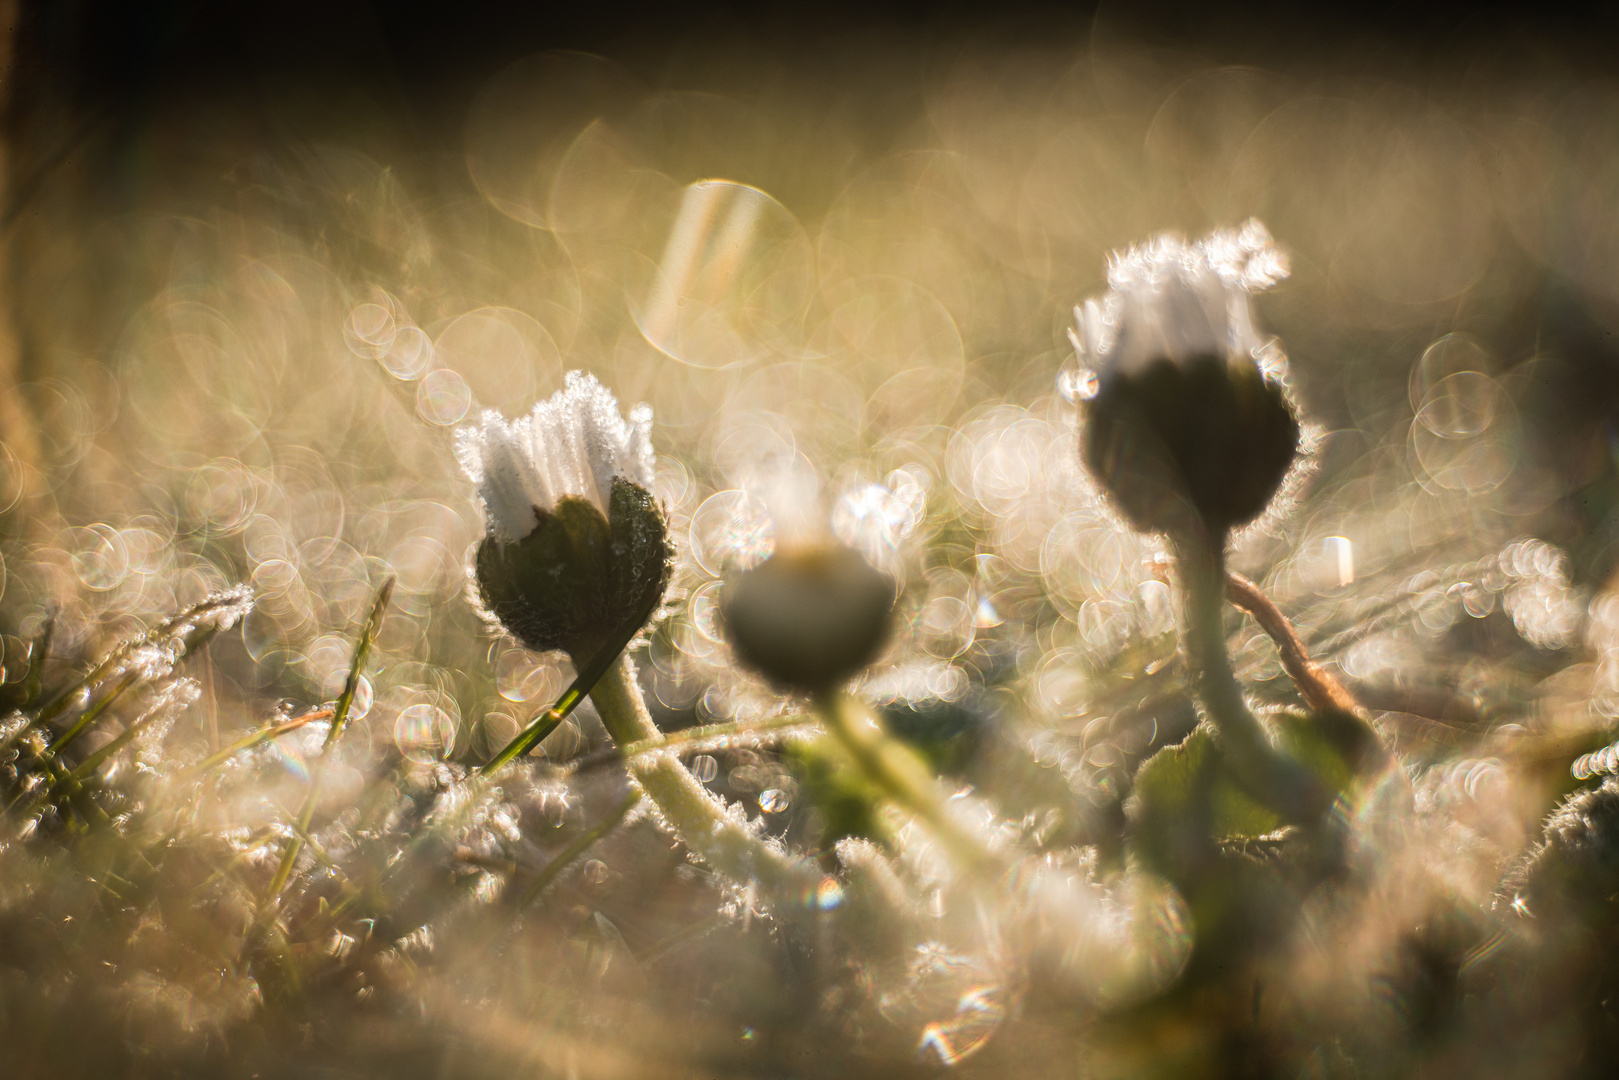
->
[1080,355,1298,536]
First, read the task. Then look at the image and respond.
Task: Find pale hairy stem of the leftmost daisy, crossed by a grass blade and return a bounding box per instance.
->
[591,656,821,897]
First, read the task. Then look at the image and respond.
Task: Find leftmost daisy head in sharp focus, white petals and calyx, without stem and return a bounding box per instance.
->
[457,371,672,665]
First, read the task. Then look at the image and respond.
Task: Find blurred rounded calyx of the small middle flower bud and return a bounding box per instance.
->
[720,546,894,693]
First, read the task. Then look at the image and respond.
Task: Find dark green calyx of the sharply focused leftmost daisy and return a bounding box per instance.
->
[474,476,674,665]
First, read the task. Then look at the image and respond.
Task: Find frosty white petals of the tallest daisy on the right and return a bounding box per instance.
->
[1069,219,1287,374]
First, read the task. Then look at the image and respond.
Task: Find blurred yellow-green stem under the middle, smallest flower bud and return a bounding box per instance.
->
[818,691,1002,874]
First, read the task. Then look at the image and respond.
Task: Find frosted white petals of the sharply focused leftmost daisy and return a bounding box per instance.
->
[455,371,652,544]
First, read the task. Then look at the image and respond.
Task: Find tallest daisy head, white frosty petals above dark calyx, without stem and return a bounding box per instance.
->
[1070,222,1300,536]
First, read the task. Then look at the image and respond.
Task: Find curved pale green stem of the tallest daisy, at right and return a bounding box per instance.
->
[1169,529,1331,823]
